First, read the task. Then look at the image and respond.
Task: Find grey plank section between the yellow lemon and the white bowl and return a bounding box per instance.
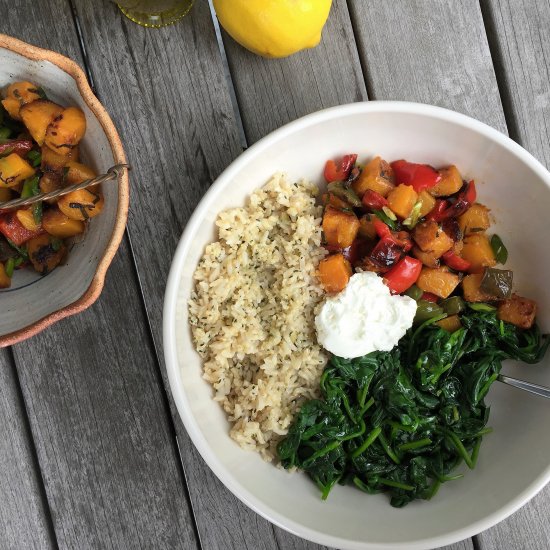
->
[223,0,367,144]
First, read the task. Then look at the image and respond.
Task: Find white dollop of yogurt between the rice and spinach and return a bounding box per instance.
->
[315,272,416,359]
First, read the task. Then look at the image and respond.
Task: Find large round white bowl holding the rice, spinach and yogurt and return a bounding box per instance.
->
[164,102,550,550]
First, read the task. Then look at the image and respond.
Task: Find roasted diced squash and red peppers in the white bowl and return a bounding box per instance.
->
[319,154,537,332]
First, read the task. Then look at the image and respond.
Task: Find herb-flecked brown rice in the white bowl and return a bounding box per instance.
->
[189,174,327,460]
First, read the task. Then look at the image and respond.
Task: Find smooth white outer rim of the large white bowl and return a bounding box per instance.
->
[163,101,550,550]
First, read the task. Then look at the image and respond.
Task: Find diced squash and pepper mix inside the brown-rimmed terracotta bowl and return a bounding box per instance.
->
[0,82,104,288]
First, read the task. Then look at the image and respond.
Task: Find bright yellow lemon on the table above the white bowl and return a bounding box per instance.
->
[214,0,332,57]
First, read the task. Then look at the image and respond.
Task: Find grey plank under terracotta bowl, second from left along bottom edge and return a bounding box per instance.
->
[0,0,201,549]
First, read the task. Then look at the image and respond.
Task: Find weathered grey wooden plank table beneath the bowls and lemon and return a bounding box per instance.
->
[0,0,550,550]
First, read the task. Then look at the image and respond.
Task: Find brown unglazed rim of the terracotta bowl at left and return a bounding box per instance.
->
[0,34,130,347]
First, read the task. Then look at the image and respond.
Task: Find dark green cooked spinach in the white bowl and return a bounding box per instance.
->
[278,309,550,507]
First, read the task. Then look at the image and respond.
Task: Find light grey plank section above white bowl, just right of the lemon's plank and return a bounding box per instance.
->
[350,0,506,131]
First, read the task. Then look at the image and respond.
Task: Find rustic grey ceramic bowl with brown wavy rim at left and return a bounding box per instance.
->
[0,34,129,346]
